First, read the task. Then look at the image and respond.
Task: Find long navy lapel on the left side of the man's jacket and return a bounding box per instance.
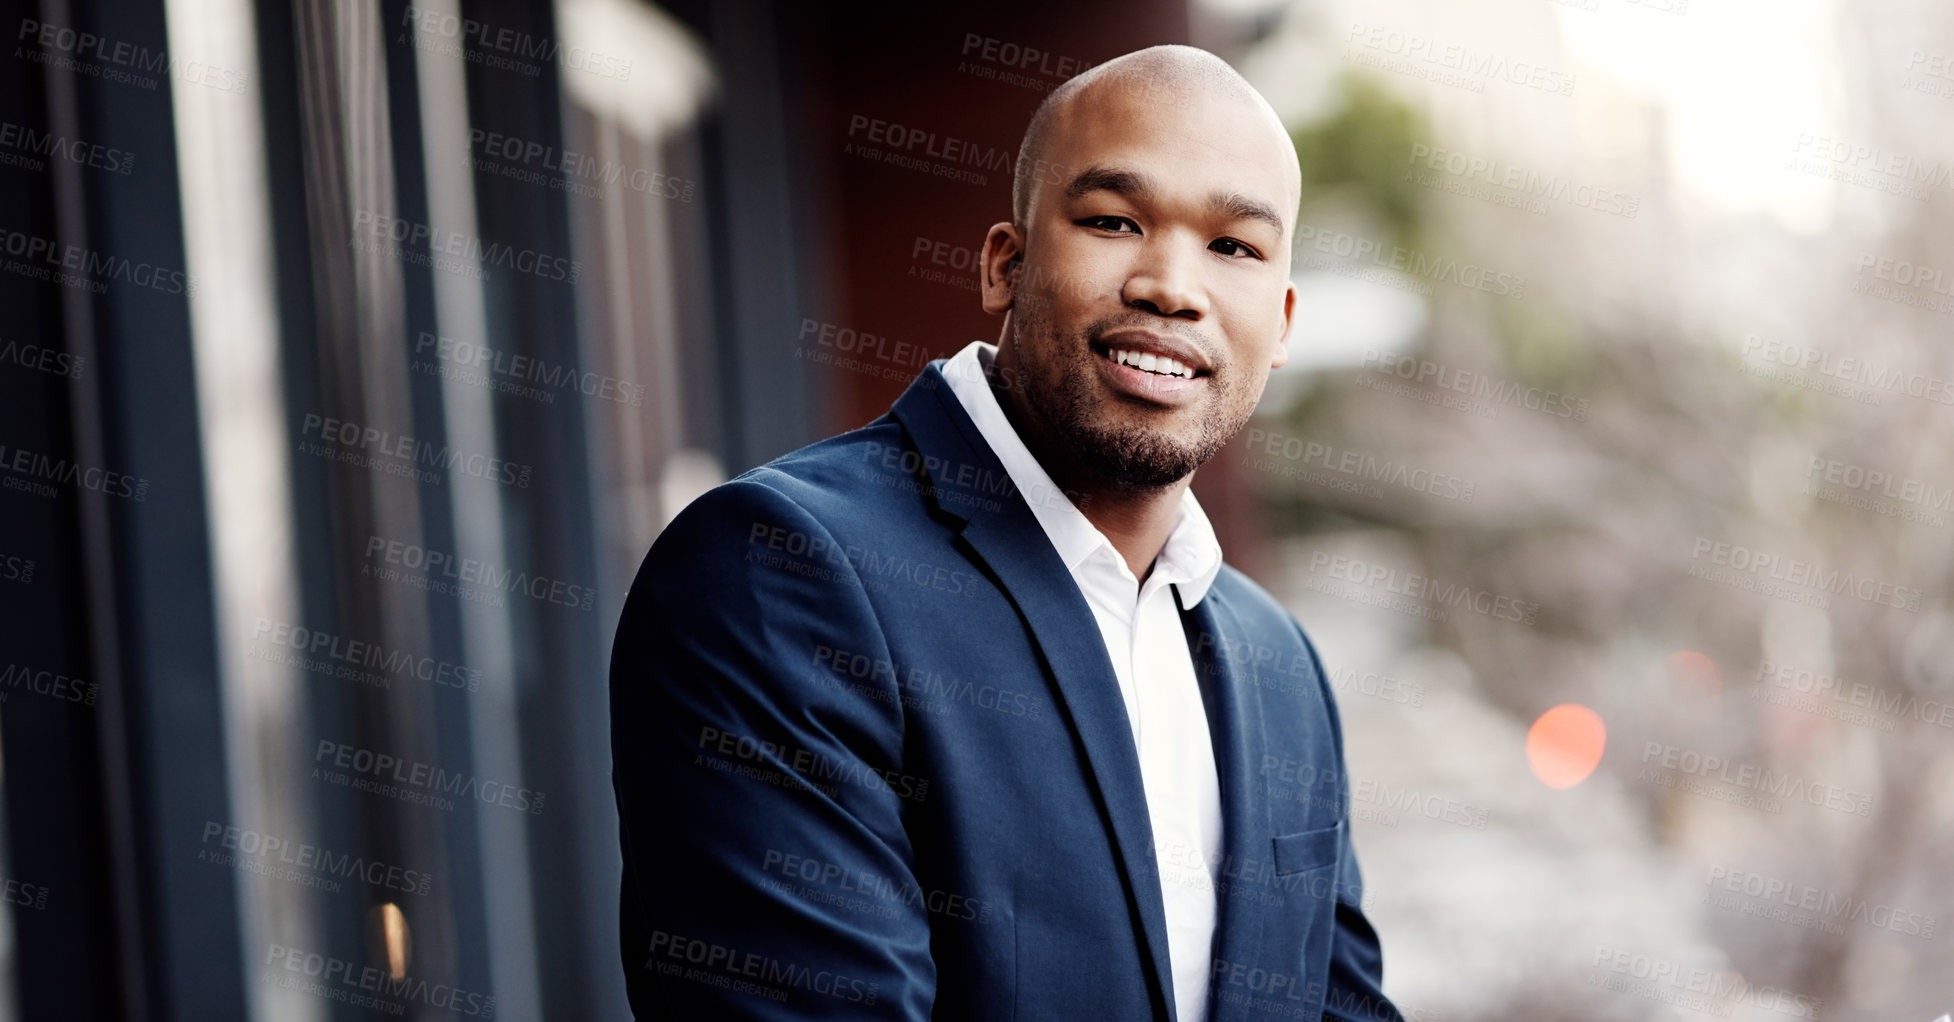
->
[891,362,1174,1018]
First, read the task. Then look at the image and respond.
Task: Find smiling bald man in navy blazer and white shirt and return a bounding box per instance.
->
[612,47,1399,1022]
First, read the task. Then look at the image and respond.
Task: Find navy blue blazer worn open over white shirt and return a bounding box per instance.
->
[610,360,1401,1022]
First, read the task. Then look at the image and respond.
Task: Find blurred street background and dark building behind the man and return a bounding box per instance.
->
[0,0,1954,1022]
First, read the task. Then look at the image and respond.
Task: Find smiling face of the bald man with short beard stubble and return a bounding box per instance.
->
[987,84,1296,490]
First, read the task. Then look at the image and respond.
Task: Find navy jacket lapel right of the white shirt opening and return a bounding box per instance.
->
[1176,586,1274,1022]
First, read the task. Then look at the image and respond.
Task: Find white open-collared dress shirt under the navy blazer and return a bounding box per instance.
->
[944,340,1221,1022]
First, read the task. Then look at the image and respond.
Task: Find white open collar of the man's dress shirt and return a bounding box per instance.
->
[942,340,1221,608]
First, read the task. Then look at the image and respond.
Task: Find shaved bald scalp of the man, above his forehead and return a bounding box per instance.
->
[1010,45,1303,227]
